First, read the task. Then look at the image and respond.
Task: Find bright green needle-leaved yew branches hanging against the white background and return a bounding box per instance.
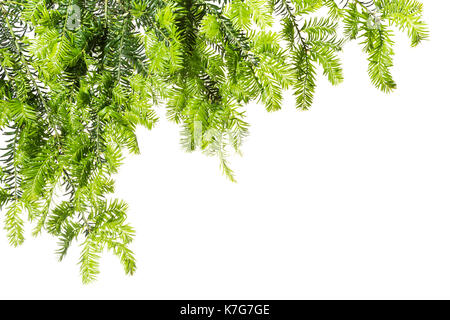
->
[0,0,428,283]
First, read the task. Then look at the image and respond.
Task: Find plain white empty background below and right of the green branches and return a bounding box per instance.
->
[0,0,450,299]
